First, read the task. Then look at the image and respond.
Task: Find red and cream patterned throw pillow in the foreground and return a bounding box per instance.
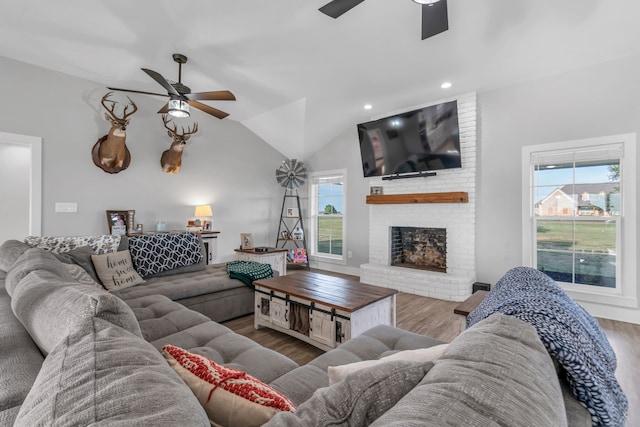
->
[162,345,295,427]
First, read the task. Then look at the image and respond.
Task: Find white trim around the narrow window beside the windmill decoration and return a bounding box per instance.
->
[308,169,347,265]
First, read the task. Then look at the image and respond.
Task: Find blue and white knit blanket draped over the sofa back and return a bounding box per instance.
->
[467,267,629,426]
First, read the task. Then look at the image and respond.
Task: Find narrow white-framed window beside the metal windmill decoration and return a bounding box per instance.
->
[309,170,346,262]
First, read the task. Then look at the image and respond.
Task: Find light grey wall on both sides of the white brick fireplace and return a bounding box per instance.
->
[307,56,640,323]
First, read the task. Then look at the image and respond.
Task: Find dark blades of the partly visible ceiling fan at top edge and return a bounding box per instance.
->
[319,0,449,40]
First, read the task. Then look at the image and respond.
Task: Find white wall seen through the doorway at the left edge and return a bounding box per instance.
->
[0,142,31,242]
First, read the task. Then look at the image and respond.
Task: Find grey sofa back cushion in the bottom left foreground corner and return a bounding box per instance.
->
[15,317,209,426]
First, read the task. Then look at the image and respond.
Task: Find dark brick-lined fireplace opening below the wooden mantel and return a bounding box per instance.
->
[390,227,447,273]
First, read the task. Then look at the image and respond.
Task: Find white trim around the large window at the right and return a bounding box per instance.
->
[522,133,638,308]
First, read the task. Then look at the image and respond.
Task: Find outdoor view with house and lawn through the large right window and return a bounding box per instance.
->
[533,159,621,288]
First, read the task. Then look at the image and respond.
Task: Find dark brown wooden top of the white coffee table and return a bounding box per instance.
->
[253,271,398,313]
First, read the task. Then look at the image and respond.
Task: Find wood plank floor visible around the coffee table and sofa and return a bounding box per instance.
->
[224,272,640,427]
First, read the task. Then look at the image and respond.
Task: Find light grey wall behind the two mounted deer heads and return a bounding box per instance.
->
[0,57,284,261]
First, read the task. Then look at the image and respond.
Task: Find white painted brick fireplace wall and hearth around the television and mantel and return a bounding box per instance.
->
[360,93,476,301]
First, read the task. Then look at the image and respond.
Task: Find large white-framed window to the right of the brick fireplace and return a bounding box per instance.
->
[523,135,636,306]
